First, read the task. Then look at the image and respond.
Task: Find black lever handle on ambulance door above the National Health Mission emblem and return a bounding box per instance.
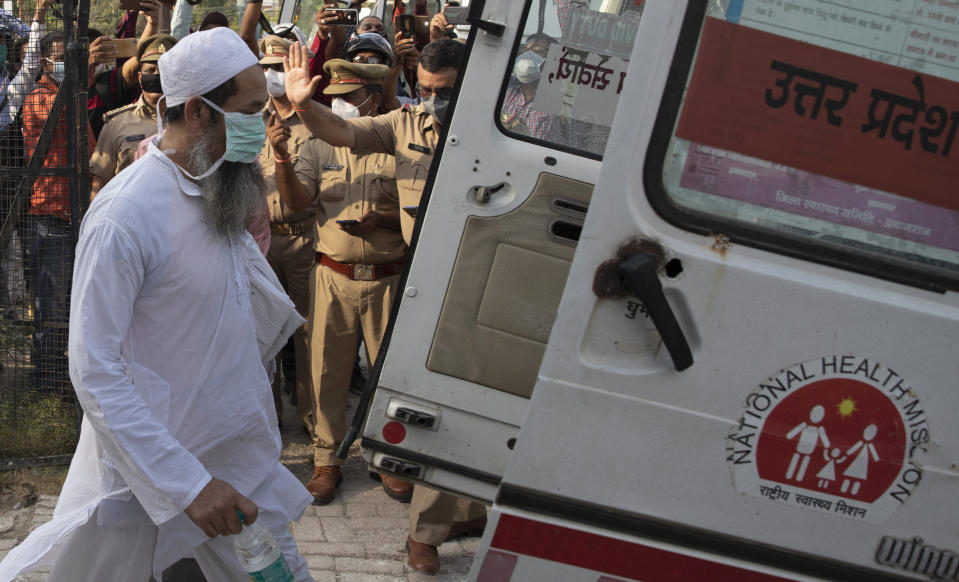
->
[619,253,693,372]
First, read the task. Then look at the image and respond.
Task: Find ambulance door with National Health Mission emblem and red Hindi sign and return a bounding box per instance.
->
[472,0,959,582]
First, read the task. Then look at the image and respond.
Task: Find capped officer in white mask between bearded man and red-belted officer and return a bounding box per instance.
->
[259,35,316,434]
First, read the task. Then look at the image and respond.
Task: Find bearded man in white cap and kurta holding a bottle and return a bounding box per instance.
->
[0,28,312,582]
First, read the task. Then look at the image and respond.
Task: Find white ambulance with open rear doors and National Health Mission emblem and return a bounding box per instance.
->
[344,0,959,582]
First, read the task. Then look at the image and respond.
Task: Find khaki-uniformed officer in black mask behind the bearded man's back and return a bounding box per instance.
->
[90,34,176,200]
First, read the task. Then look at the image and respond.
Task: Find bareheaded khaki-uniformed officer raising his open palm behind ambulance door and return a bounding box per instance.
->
[286,39,486,574]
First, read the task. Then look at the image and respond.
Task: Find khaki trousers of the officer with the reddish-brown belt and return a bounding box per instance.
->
[307,265,399,466]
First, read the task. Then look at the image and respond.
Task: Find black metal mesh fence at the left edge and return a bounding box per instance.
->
[0,0,90,469]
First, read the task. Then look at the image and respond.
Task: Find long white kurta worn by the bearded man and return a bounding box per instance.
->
[0,145,312,581]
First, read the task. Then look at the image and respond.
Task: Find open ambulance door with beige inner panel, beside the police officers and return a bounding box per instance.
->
[354,0,640,502]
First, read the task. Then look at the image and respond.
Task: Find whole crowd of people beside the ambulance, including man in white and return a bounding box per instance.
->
[0,0,568,581]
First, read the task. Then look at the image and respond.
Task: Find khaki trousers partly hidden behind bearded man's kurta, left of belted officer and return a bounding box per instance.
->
[266,231,315,432]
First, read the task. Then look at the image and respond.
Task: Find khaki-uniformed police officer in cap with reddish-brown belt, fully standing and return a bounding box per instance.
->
[277,59,412,505]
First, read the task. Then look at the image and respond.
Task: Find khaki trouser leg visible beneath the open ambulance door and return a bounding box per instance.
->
[410,485,486,546]
